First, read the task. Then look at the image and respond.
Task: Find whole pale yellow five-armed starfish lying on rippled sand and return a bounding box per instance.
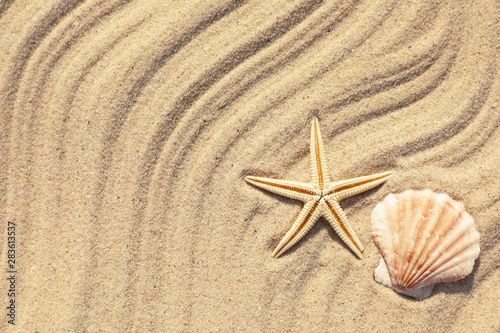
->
[245,118,392,259]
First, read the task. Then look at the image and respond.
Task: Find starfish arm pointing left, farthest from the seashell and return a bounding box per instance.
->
[245,176,318,202]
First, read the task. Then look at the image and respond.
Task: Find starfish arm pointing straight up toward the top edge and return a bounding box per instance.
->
[310,118,330,190]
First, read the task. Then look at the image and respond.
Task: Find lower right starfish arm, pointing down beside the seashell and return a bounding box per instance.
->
[324,198,363,259]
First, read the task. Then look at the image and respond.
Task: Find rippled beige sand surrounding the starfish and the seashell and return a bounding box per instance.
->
[0,0,500,333]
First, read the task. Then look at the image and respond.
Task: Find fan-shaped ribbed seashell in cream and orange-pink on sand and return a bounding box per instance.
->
[371,190,479,299]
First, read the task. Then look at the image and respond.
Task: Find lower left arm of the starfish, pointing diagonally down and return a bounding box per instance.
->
[273,200,320,257]
